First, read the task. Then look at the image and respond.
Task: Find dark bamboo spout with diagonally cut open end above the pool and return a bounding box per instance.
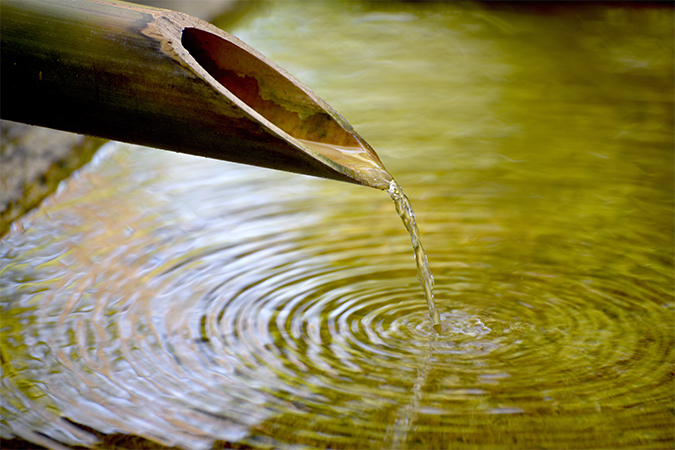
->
[0,0,392,189]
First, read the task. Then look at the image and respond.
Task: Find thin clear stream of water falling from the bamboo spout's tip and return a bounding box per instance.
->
[389,180,441,332]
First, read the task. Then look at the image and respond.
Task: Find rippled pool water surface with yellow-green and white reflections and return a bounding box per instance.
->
[0,2,675,449]
